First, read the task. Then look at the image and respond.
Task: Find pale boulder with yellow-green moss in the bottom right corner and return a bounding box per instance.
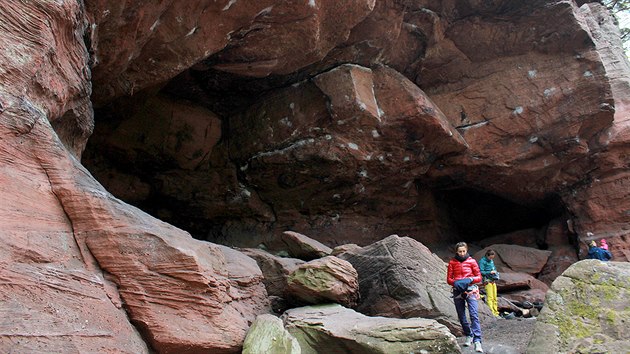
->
[527,260,630,353]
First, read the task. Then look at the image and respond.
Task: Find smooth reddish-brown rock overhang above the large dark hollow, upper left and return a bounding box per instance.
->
[86,0,375,103]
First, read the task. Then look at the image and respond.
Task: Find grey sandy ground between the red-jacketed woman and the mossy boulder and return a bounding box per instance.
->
[457,317,536,354]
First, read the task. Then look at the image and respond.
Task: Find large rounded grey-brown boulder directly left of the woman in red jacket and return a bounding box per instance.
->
[339,235,483,333]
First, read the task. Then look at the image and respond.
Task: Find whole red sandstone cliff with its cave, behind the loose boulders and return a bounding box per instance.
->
[0,0,630,353]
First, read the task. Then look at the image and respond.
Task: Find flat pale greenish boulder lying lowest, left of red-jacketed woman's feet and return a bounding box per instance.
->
[282,304,461,354]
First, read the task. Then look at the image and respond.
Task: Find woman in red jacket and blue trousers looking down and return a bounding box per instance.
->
[446,242,483,353]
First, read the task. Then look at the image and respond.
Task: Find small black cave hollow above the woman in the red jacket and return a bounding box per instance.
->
[436,188,565,242]
